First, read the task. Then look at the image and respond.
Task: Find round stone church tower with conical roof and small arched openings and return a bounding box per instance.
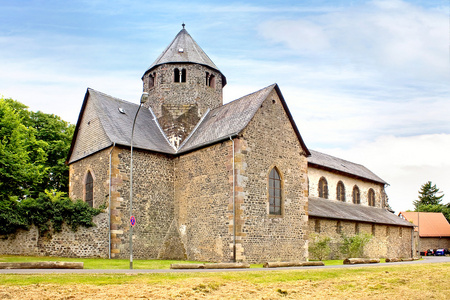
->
[142,24,227,148]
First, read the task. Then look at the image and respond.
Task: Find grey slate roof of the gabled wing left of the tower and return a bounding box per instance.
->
[68,88,175,163]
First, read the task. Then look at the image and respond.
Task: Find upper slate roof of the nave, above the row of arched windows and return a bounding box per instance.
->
[308,150,387,184]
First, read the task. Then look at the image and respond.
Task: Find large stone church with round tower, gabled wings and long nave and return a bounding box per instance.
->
[68,25,413,263]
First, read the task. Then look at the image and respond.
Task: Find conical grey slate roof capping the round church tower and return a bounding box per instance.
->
[144,24,226,86]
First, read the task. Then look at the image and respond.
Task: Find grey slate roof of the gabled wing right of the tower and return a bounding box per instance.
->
[178,84,309,155]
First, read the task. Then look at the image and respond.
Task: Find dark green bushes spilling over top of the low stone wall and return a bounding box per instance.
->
[0,190,104,235]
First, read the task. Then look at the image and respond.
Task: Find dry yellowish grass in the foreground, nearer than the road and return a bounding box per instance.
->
[0,257,450,299]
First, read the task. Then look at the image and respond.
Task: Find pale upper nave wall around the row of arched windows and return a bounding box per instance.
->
[308,166,384,208]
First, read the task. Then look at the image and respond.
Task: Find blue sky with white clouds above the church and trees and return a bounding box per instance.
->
[0,0,450,213]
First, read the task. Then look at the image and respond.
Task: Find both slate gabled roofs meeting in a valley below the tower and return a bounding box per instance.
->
[68,84,310,163]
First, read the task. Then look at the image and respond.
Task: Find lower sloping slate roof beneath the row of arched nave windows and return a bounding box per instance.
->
[308,197,414,227]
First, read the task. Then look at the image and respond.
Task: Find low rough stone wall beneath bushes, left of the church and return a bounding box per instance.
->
[0,213,108,258]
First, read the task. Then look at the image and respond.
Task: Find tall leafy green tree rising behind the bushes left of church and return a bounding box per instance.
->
[0,98,74,199]
